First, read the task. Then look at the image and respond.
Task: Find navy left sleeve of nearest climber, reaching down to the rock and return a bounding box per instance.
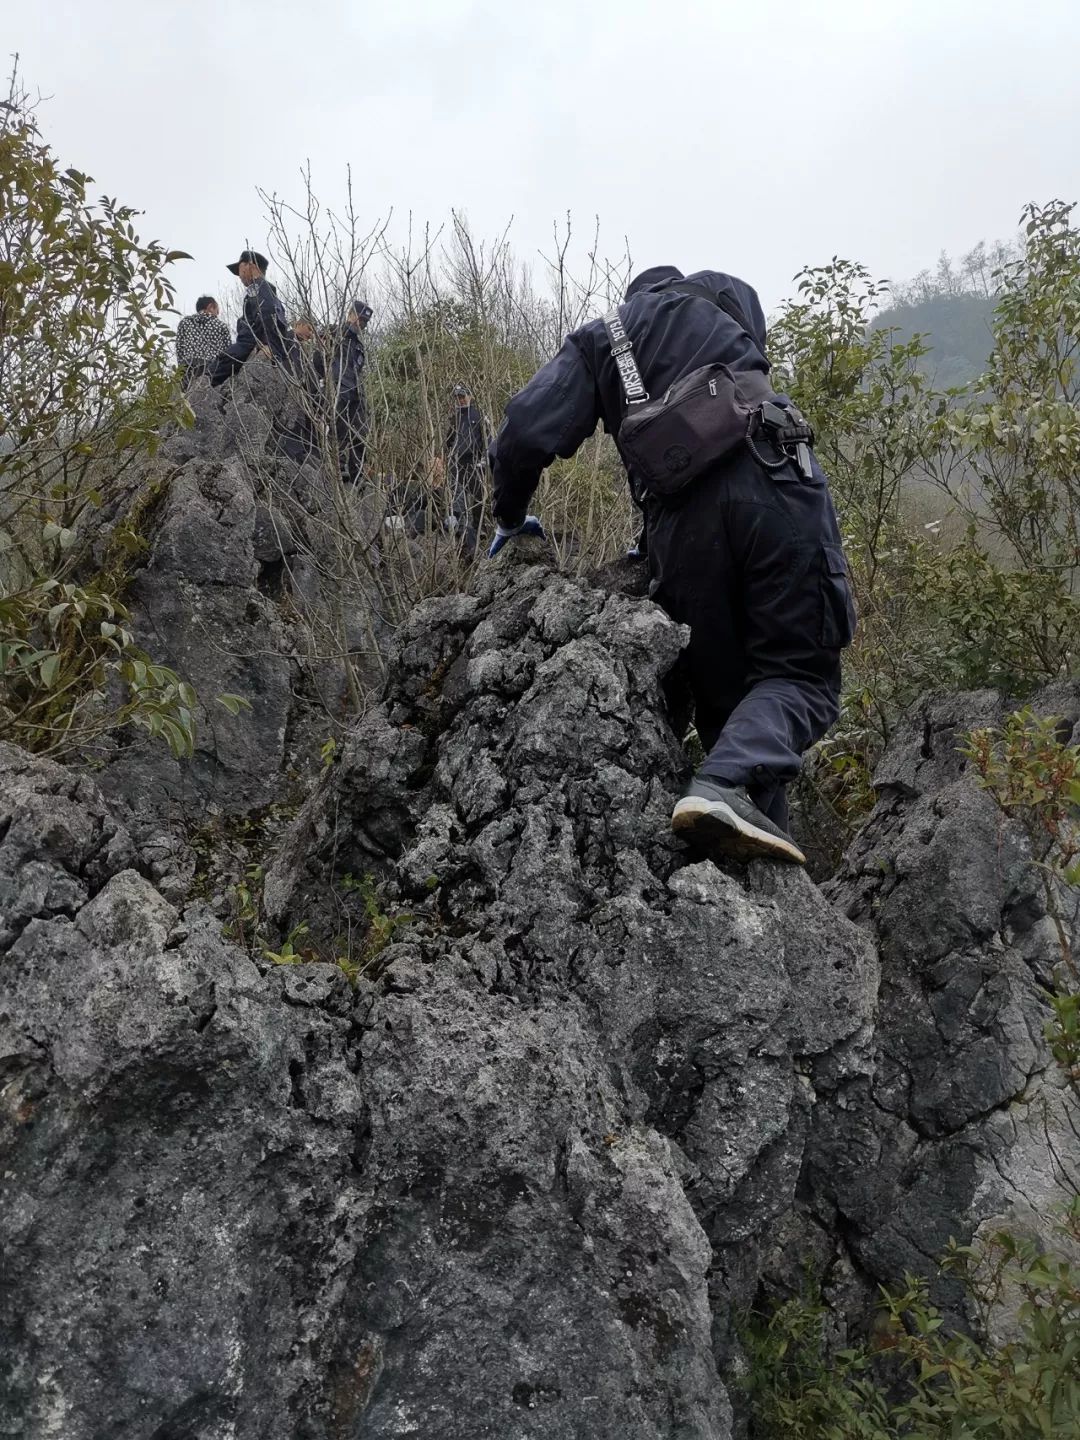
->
[490,336,600,527]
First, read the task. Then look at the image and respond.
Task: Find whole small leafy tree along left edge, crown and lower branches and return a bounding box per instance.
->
[0,68,204,755]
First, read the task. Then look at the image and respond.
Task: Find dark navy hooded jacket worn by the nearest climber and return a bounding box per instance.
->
[491,265,769,527]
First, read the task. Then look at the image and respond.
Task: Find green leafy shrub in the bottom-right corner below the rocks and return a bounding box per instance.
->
[743,1221,1080,1440]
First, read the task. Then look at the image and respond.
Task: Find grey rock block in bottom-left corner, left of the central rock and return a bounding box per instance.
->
[0,746,366,1440]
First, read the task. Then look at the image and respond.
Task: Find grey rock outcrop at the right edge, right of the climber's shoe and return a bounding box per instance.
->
[804,685,1080,1324]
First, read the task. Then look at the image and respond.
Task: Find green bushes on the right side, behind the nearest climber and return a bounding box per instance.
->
[772,202,1080,822]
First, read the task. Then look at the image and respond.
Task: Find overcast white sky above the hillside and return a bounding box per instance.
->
[3,0,1080,318]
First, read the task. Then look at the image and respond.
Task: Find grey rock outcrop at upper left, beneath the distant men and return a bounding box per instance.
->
[95,360,379,899]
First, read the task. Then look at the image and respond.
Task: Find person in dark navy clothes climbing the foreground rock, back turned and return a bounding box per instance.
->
[491,265,855,863]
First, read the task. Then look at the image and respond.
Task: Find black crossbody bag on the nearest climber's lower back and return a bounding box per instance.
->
[619,363,775,500]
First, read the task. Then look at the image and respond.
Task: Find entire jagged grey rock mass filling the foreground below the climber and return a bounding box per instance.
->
[0,546,1080,1440]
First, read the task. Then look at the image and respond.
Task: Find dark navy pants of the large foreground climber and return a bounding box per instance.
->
[647,442,855,825]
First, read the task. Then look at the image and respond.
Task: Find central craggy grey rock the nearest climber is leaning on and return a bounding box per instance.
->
[266,564,877,1437]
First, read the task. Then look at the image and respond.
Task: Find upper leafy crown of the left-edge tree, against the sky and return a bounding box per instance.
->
[0,66,187,576]
